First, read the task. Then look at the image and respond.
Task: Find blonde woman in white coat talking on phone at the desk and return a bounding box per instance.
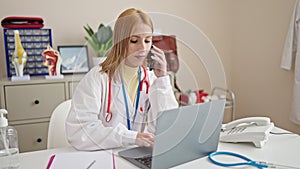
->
[66,8,178,150]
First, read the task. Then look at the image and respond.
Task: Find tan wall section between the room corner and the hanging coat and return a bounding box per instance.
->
[231,0,300,133]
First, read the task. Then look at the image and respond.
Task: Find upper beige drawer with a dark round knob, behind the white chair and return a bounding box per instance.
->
[4,83,65,122]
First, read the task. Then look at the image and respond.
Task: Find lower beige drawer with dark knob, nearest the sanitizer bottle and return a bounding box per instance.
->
[13,122,49,152]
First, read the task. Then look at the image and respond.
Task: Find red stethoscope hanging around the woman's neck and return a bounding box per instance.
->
[105,67,150,123]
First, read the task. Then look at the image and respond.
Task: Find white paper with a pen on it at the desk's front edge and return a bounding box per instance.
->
[47,151,115,169]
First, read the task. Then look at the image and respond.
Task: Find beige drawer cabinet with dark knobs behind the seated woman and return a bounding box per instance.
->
[0,76,82,152]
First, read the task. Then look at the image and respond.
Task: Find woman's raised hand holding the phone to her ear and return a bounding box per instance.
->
[151,45,167,77]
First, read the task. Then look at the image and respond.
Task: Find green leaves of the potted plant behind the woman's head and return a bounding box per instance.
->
[84,23,112,57]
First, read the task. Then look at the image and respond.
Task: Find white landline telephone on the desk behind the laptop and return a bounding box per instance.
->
[220,117,274,148]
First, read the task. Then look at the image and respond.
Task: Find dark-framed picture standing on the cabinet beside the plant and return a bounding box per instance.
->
[57,45,89,74]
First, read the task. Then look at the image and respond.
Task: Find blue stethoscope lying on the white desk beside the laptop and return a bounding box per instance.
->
[208,151,300,169]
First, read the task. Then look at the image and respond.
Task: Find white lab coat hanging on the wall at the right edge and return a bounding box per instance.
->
[281,1,300,124]
